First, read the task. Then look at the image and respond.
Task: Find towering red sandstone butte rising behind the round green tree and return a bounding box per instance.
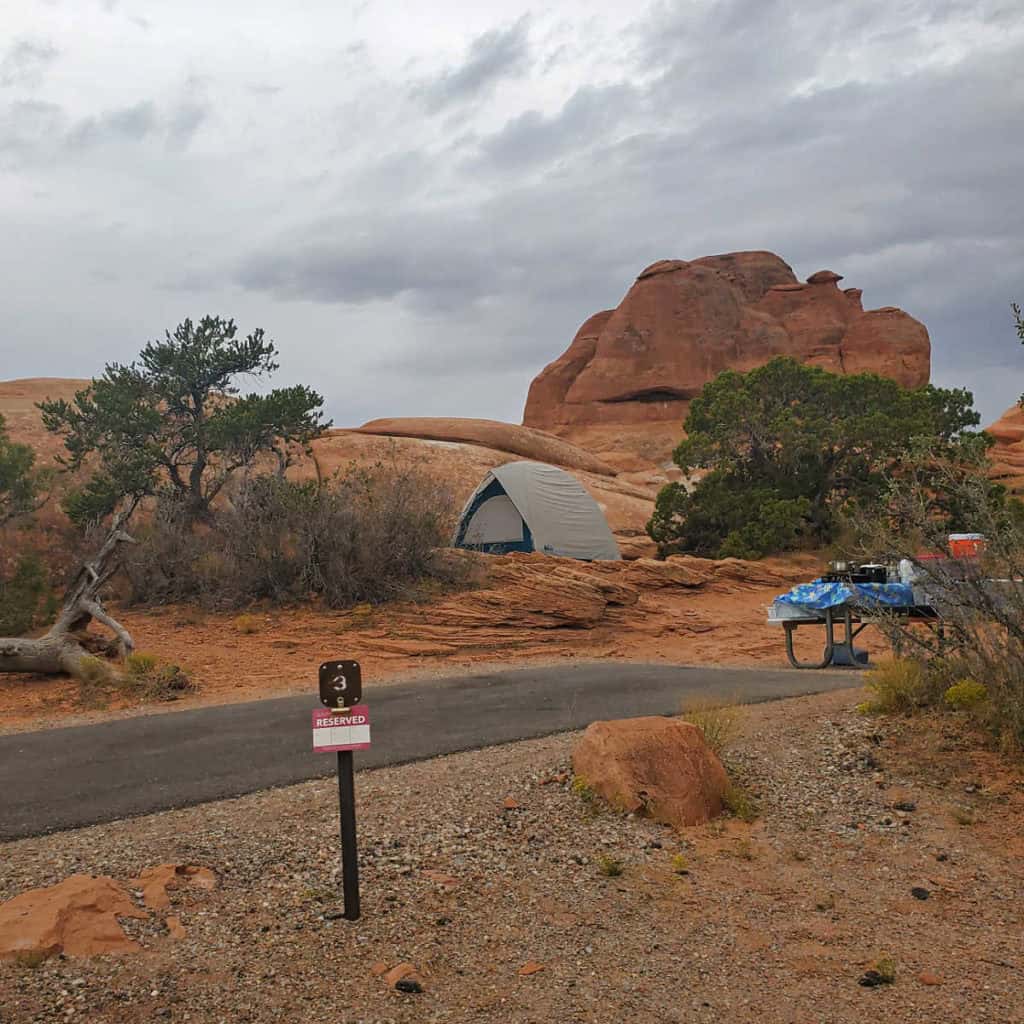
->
[523,252,931,469]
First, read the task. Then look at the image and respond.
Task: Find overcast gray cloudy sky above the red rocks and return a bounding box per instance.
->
[0,0,1024,425]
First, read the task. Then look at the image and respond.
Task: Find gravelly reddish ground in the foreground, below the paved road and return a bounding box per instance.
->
[0,691,1024,1024]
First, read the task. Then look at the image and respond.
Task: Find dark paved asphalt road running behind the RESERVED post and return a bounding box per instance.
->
[0,662,857,840]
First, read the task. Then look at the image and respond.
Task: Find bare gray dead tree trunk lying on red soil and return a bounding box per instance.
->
[0,516,135,676]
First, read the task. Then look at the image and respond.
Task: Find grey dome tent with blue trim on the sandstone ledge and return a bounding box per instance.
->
[454,462,622,561]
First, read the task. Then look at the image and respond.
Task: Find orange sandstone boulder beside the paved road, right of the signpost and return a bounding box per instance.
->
[572,718,728,828]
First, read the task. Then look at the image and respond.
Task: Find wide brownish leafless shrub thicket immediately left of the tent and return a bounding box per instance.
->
[126,464,455,608]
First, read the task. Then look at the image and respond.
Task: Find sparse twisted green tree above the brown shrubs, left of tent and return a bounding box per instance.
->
[39,316,330,522]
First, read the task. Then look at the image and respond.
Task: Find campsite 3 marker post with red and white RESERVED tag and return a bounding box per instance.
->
[313,660,370,921]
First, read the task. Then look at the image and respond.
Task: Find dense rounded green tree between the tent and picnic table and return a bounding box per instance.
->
[647,357,979,557]
